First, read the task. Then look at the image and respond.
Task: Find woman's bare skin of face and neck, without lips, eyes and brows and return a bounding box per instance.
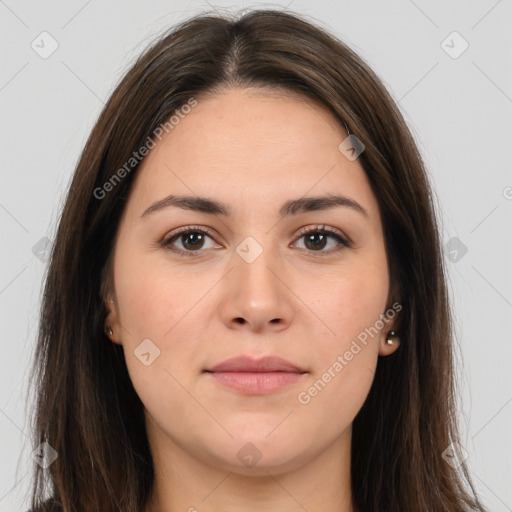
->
[105,88,398,512]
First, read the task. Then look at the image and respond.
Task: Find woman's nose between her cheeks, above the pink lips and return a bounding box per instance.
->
[219,241,294,333]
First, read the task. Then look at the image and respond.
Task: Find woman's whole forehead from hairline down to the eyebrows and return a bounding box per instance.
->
[124,89,376,222]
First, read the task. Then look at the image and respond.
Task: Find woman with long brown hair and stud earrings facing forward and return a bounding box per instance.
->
[27,10,485,512]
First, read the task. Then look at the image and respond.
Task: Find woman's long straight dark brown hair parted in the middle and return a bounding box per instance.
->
[27,10,485,512]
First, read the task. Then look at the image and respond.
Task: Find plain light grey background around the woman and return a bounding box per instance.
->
[0,0,512,512]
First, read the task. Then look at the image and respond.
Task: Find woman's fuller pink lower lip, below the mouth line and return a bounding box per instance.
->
[208,372,305,395]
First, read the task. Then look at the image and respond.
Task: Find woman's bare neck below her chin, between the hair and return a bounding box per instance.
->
[144,428,356,512]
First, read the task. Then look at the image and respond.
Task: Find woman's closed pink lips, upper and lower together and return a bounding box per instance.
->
[205,356,307,395]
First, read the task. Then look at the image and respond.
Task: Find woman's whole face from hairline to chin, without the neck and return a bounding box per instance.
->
[107,89,397,474]
